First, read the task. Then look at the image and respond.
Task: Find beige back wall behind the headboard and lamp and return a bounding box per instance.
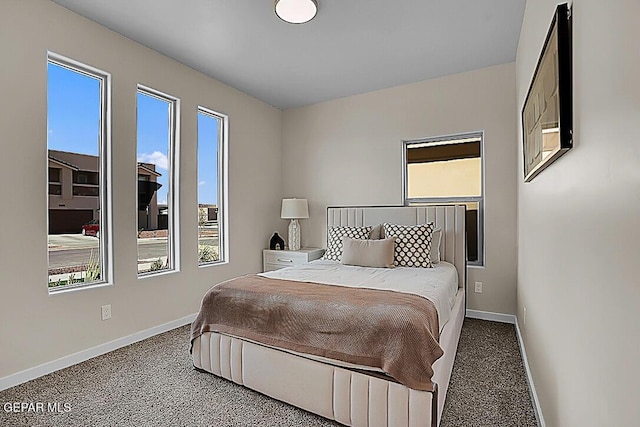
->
[280,64,517,314]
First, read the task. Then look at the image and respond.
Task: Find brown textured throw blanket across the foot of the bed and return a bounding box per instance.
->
[191,275,443,391]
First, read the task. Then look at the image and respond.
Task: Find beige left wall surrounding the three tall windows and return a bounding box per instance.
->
[0,0,282,378]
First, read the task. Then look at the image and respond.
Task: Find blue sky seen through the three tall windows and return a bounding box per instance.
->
[47,63,219,208]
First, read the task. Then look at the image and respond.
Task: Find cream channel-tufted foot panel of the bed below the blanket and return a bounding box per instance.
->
[193,332,433,427]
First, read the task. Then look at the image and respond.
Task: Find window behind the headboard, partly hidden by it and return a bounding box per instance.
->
[403,132,484,265]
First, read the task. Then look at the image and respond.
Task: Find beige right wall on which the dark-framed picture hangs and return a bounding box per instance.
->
[516,0,640,427]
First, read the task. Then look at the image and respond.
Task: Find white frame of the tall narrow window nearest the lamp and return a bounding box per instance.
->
[196,105,229,268]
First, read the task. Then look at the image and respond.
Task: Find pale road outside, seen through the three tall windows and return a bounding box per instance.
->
[49,234,218,269]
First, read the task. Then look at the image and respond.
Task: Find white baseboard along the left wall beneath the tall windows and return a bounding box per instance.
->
[0,313,197,391]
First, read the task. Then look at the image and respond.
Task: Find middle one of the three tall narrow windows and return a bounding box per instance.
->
[137,86,179,276]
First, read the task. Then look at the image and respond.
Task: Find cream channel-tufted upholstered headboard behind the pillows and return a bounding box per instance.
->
[327,205,467,289]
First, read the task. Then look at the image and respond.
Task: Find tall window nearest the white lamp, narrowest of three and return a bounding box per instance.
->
[198,107,227,265]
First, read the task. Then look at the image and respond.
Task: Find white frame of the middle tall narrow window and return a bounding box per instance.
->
[135,83,181,279]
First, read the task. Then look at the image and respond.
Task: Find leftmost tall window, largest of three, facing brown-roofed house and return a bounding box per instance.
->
[47,53,112,293]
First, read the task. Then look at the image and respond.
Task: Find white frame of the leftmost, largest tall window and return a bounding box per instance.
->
[46,51,114,295]
